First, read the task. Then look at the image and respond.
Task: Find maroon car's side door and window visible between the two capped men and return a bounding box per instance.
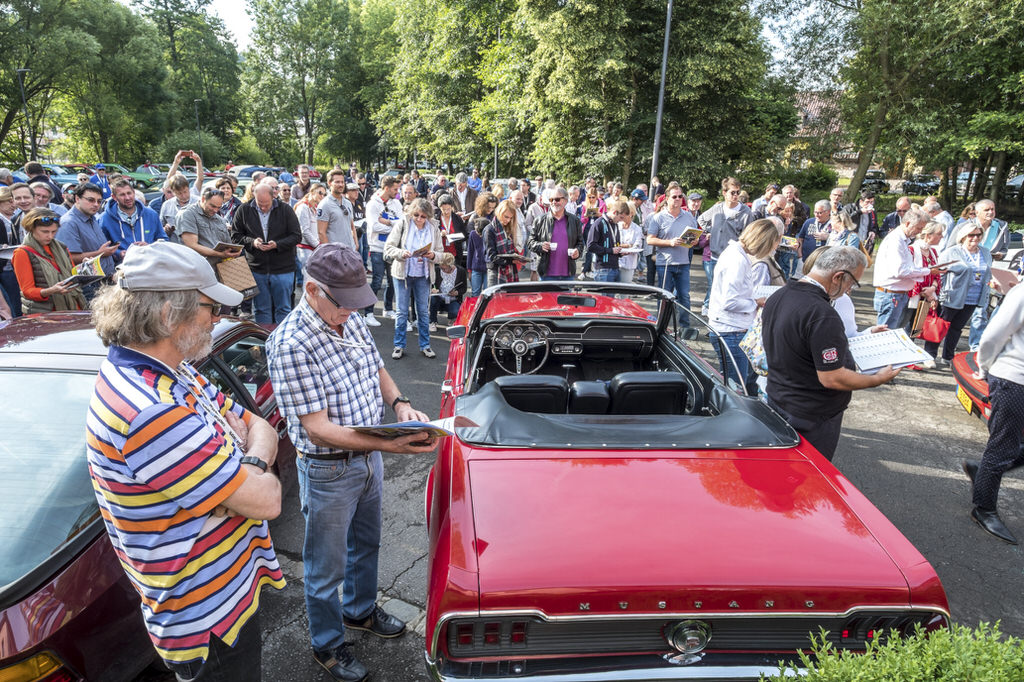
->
[200,329,295,488]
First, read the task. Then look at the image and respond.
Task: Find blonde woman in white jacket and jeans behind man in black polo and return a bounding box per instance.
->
[708,219,781,387]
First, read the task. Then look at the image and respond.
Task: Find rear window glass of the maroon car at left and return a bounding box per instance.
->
[0,372,99,586]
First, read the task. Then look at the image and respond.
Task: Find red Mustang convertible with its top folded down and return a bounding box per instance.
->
[425,282,949,681]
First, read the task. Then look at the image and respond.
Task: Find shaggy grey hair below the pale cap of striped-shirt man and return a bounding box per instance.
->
[92,286,199,346]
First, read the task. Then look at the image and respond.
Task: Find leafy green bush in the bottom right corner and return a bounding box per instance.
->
[763,623,1024,682]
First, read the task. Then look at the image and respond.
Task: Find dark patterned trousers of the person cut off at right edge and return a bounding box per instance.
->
[974,377,1024,511]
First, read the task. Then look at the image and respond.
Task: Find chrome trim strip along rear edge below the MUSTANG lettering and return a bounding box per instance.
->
[425,604,950,658]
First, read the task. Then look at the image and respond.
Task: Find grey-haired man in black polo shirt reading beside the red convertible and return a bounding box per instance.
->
[761,241,899,461]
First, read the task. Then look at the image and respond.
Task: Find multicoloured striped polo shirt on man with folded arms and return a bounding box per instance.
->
[86,346,285,663]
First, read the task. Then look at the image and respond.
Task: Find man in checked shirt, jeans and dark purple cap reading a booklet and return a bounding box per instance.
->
[266,244,435,680]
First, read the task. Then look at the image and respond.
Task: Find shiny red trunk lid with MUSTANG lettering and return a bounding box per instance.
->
[470,451,910,614]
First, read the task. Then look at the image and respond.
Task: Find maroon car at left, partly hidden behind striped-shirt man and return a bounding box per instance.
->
[0,313,295,682]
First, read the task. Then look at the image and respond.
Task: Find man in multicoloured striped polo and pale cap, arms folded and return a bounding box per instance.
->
[87,242,285,682]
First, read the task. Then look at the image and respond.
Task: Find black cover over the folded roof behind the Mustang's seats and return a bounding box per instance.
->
[455,382,800,450]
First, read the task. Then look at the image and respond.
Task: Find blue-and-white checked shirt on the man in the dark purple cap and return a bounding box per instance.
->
[266,297,384,456]
